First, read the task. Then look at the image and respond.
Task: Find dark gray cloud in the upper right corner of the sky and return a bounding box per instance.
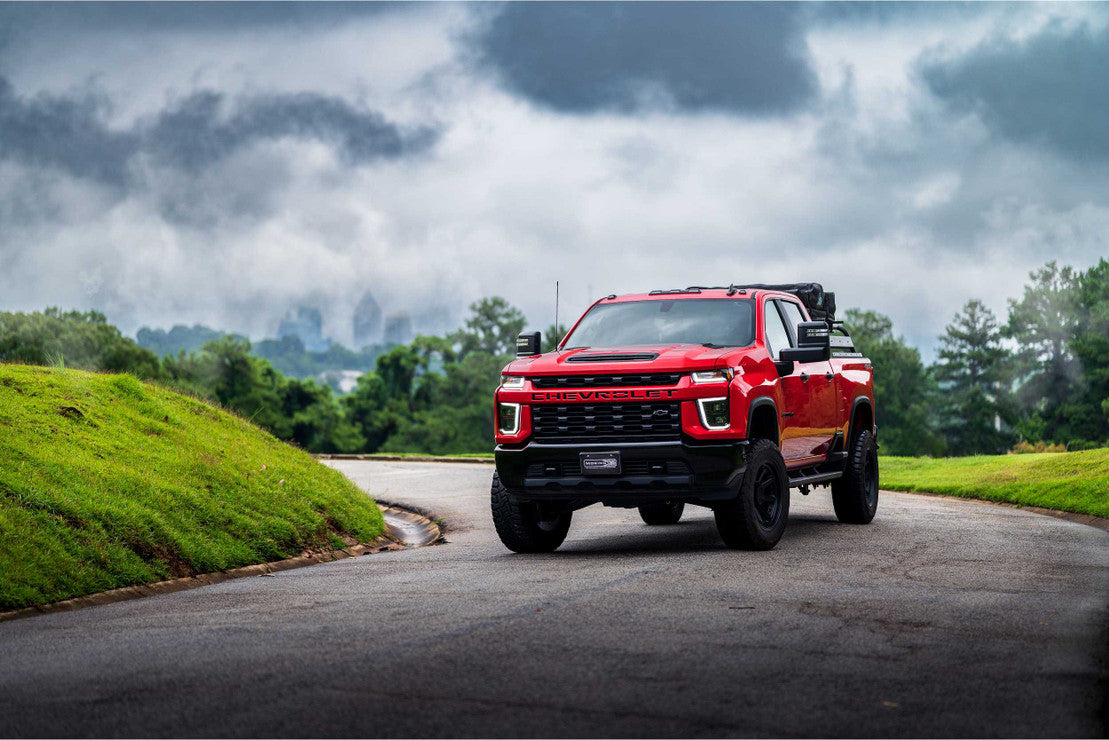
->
[922,24,1109,159]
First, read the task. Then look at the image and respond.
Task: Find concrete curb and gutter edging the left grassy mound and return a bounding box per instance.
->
[0,504,446,622]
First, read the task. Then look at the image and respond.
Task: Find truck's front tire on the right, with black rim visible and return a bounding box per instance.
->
[714,439,790,550]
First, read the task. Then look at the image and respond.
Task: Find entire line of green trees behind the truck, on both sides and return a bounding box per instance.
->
[0,260,1109,456]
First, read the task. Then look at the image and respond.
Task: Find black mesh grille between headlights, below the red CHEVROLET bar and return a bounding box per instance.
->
[531,403,682,444]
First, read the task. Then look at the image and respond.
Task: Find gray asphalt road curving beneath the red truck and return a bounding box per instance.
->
[0,462,1109,737]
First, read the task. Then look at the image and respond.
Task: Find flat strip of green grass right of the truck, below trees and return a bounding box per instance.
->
[881,449,1109,517]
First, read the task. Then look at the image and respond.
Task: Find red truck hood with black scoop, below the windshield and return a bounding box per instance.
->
[505,344,739,375]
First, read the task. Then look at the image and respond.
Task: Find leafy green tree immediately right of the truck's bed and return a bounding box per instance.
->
[844,308,944,455]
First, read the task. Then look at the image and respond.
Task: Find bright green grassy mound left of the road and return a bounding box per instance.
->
[0,365,383,609]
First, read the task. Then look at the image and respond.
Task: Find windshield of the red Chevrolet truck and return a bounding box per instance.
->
[563,298,755,349]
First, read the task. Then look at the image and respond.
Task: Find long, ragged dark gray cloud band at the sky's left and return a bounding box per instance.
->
[0,78,436,186]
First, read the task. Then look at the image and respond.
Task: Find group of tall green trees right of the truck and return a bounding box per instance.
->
[844,260,1109,456]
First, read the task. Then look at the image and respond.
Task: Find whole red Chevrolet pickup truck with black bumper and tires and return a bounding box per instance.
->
[491,283,878,553]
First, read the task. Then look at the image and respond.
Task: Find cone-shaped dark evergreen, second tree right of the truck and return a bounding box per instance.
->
[935,301,1013,455]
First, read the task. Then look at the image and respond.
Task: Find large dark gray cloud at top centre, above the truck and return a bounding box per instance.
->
[479,2,816,114]
